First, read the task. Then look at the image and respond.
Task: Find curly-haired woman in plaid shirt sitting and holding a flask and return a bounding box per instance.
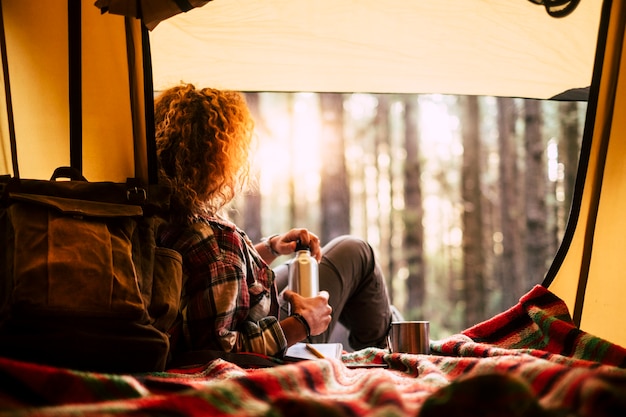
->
[155,84,391,357]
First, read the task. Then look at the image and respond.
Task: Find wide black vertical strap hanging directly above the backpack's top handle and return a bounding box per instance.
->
[67,0,83,174]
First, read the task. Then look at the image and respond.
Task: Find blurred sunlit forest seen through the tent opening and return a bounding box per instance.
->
[228,92,587,339]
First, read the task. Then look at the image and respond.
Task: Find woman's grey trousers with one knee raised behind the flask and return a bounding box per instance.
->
[274,236,392,350]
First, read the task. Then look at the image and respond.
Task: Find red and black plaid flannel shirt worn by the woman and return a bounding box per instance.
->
[159,217,287,357]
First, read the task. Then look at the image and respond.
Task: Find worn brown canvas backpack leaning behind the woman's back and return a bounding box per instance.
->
[0,172,182,373]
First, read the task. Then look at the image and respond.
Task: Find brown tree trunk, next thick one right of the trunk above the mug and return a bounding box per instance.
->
[460,96,487,327]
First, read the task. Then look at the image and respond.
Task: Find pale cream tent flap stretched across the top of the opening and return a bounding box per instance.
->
[151,0,602,98]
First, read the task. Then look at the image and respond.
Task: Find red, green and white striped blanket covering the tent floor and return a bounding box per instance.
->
[0,286,626,417]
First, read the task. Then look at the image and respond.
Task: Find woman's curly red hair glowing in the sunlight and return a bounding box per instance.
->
[154,84,254,218]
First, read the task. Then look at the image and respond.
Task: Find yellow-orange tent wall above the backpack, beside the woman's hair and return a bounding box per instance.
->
[0,0,151,181]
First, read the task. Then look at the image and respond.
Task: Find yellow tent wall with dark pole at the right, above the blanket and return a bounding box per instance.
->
[544,0,626,346]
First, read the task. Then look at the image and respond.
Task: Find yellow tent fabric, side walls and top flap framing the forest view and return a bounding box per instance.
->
[0,0,626,345]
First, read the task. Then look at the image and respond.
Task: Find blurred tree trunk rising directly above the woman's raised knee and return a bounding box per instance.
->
[319,93,350,243]
